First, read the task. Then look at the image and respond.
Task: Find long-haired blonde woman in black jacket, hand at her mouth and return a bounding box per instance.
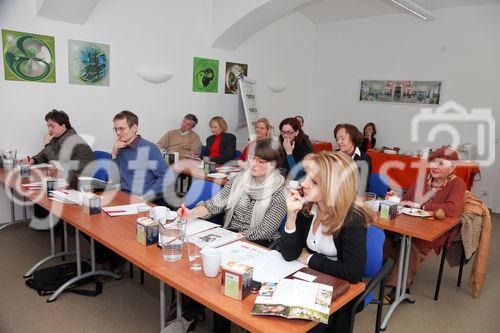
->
[279,151,372,332]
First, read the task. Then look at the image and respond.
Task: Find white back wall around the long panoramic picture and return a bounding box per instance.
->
[306,5,500,212]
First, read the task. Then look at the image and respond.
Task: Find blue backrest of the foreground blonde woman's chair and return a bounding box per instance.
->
[363,225,385,306]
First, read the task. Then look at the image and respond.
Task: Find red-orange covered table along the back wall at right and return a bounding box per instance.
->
[367,151,480,190]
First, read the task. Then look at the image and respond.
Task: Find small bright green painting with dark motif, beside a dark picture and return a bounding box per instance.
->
[193,57,219,93]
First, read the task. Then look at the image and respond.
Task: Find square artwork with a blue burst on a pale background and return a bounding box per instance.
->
[68,39,110,86]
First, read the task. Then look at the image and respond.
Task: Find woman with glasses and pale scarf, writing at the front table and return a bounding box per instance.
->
[162,139,286,333]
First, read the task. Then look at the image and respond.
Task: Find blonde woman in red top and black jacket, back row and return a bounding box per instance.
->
[205,116,236,164]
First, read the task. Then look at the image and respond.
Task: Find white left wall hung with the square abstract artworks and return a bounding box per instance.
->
[0,0,314,222]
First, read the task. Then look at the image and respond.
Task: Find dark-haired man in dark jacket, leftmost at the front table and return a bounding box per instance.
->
[25,110,94,230]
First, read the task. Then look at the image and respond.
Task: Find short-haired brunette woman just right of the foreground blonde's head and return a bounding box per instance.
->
[333,124,372,194]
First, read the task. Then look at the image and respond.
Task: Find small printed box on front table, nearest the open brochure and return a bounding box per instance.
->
[221,261,253,301]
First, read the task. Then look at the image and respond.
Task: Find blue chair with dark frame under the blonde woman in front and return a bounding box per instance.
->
[350,225,393,333]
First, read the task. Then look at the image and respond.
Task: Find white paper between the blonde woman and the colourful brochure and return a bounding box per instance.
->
[242,250,306,282]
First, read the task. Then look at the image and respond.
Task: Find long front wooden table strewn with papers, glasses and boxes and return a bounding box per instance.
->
[0,170,365,333]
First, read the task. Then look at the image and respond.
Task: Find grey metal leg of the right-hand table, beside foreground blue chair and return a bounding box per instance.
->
[380,235,415,330]
